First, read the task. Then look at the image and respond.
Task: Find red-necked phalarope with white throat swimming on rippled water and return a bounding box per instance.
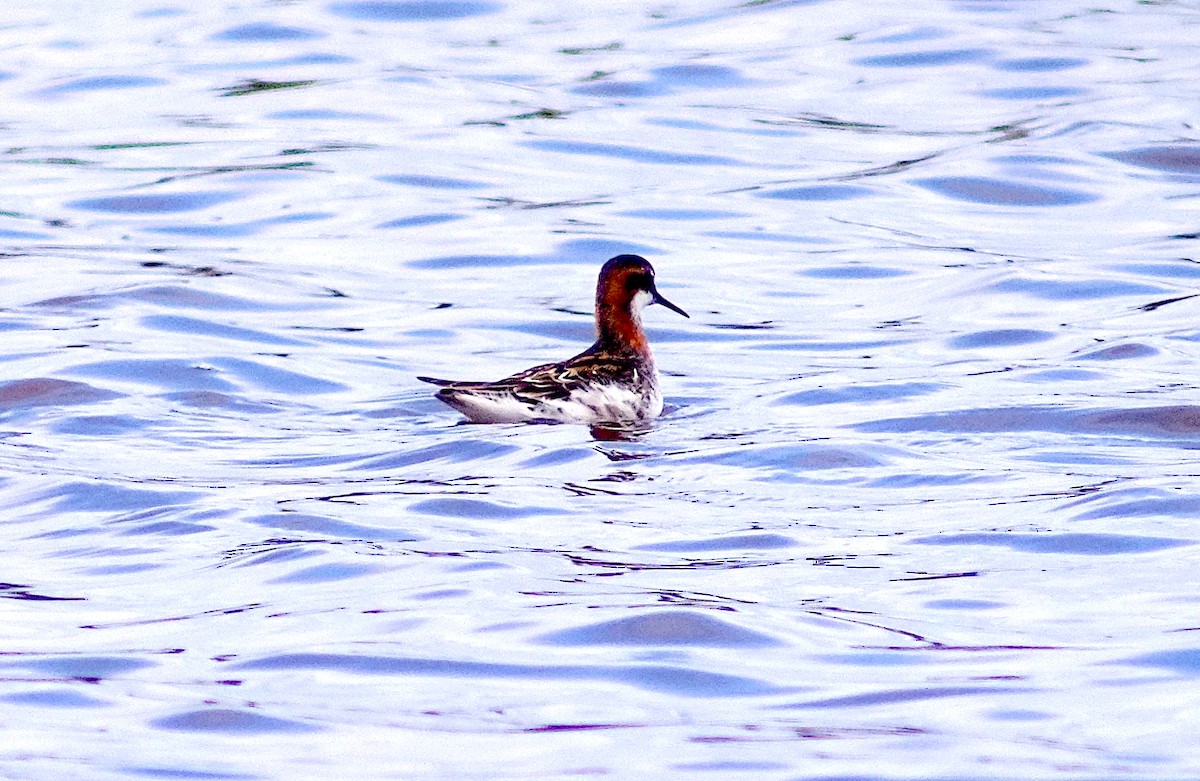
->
[416,254,689,425]
